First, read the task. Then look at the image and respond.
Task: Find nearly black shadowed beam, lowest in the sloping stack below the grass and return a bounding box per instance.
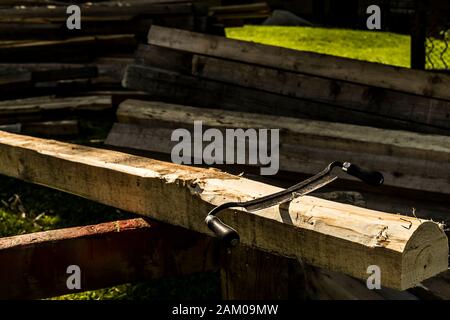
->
[122,65,440,134]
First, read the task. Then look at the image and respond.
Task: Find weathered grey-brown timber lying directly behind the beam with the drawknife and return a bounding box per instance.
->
[106,100,450,193]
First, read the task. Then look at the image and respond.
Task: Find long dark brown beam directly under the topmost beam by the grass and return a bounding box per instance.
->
[191,55,450,132]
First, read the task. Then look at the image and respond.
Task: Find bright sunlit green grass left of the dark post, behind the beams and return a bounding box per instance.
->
[226,26,410,68]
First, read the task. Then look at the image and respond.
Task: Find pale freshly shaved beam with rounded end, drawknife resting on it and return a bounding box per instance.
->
[0,132,448,289]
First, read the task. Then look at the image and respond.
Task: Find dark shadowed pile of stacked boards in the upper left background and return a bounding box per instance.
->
[0,0,268,133]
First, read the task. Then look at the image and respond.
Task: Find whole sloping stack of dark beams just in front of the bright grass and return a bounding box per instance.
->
[123,26,450,135]
